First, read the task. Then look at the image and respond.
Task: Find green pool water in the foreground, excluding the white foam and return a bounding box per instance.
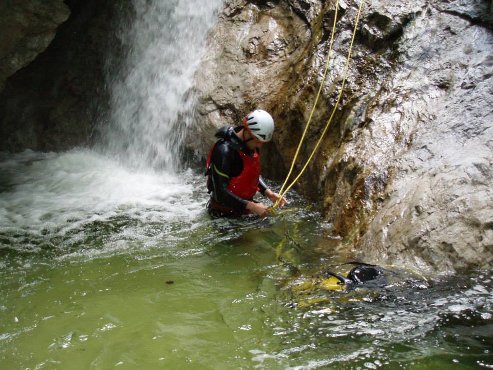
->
[0,213,493,369]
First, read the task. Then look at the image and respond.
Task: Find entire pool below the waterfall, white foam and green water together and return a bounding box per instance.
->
[0,151,493,369]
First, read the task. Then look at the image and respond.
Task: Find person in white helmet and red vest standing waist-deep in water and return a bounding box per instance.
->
[206,109,286,217]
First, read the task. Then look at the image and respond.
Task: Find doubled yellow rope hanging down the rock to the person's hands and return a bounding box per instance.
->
[273,0,364,208]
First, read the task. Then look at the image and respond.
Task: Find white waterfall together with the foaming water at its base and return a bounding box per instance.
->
[0,0,222,251]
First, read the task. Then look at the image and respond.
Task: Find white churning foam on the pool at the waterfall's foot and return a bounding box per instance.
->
[0,150,203,238]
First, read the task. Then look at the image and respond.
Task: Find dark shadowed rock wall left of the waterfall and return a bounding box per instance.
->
[0,0,122,151]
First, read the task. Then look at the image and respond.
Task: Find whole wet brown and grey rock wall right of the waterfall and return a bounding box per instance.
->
[192,0,493,273]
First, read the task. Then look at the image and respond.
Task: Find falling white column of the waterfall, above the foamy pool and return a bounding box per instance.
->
[103,0,222,172]
